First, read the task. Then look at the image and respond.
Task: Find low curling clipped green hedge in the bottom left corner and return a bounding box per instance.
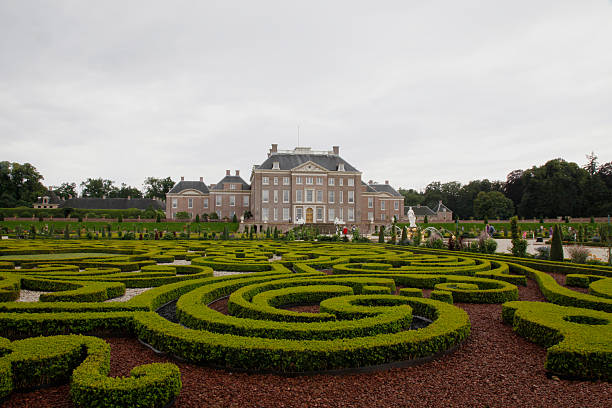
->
[0,335,181,407]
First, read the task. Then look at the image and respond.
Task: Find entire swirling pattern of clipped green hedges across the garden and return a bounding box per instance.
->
[0,241,612,406]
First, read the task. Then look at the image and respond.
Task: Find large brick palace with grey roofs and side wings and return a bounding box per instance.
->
[166,144,405,232]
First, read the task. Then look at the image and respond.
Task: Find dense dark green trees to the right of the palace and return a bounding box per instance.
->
[399,153,612,219]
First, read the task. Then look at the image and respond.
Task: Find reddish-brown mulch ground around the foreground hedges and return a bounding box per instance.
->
[5,280,612,408]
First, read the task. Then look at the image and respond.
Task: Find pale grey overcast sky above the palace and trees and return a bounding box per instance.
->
[0,0,612,193]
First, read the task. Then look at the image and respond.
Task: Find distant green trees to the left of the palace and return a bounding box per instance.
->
[0,161,174,208]
